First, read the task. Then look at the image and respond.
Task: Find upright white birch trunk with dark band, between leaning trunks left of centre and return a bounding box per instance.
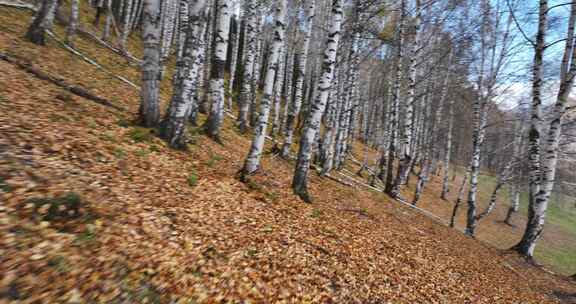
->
[205,0,230,142]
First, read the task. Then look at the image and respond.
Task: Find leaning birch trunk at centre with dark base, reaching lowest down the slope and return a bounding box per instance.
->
[292,0,344,202]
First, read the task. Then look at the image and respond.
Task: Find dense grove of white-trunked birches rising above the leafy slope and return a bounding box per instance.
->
[24,0,576,268]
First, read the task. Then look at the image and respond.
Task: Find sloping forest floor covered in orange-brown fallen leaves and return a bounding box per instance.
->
[0,2,576,303]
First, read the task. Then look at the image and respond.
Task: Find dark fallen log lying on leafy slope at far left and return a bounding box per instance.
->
[0,53,126,111]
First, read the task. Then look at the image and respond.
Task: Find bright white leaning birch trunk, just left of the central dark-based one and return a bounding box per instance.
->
[241,0,287,179]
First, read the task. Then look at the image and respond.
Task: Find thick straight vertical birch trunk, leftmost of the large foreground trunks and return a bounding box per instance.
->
[139,0,162,127]
